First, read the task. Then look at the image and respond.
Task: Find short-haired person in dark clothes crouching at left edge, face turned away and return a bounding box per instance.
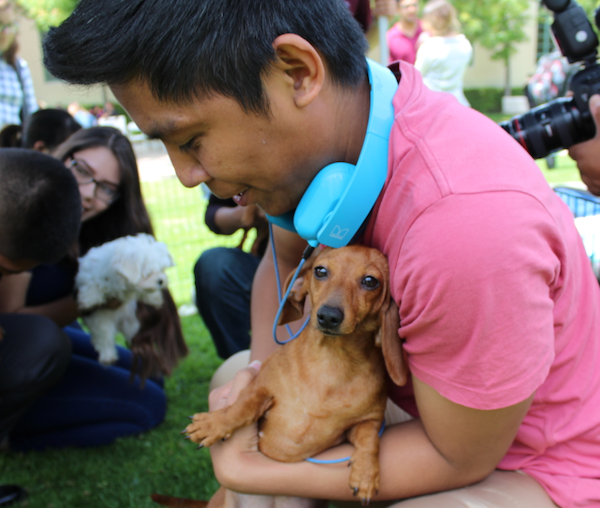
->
[0,148,81,500]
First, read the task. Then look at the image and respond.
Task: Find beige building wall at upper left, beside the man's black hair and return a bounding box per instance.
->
[19,15,115,107]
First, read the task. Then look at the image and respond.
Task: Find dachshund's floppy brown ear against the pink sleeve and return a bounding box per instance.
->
[375,297,408,386]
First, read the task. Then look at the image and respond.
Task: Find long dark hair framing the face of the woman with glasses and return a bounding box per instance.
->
[54,127,154,256]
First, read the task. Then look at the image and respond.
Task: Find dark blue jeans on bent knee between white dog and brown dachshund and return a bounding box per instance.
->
[194,247,260,359]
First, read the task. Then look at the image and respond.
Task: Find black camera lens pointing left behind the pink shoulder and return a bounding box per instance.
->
[500,98,583,159]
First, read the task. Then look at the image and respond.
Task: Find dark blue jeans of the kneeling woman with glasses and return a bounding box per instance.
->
[10,325,167,451]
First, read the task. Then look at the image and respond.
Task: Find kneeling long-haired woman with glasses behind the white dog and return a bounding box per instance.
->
[0,127,187,450]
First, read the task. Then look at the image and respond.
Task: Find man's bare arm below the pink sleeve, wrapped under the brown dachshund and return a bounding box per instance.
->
[210,369,533,500]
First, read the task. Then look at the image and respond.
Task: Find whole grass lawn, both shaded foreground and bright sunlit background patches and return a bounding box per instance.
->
[0,123,579,508]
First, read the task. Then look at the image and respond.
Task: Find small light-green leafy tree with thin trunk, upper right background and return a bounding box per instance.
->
[453,0,533,95]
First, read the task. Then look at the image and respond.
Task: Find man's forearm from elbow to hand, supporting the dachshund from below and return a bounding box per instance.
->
[211,420,491,501]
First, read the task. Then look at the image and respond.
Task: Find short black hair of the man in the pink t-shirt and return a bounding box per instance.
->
[44,0,367,114]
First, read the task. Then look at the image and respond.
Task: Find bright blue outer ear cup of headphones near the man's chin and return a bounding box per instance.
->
[294,162,356,243]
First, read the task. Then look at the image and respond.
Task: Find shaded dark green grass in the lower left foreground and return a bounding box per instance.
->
[0,316,220,508]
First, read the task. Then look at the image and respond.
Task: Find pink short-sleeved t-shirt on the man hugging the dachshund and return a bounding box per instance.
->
[365,64,600,507]
